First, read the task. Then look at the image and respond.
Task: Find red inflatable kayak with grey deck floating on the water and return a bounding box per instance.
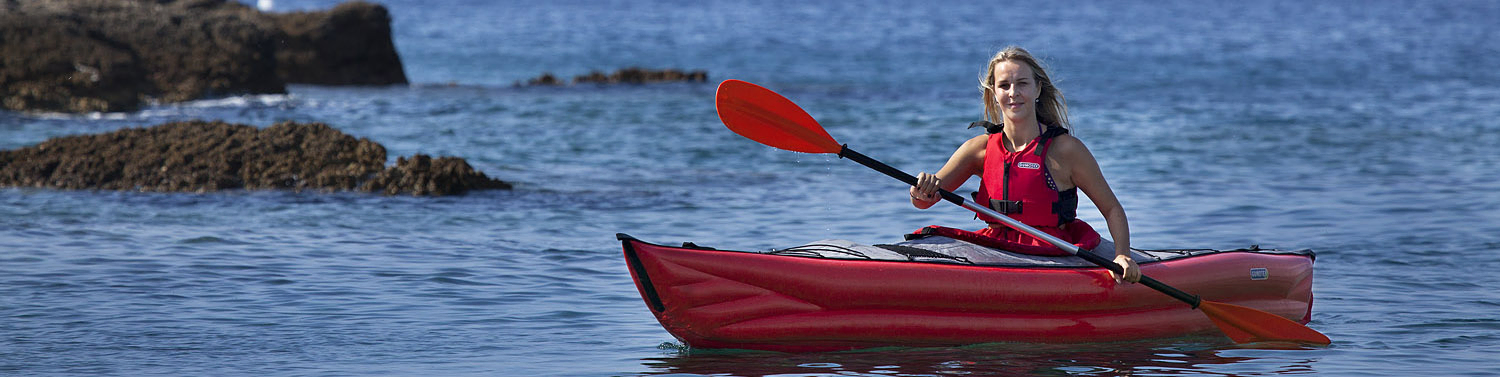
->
[617,234,1314,351]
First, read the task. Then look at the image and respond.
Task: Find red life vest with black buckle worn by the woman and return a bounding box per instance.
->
[974,126,1079,227]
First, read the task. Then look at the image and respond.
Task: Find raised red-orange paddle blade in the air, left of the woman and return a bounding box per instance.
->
[714,80,843,153]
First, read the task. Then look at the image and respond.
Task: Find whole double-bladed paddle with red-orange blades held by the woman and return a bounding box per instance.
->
[714,80,1332,345]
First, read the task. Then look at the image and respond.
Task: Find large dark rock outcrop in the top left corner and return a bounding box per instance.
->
[0,0,407,113]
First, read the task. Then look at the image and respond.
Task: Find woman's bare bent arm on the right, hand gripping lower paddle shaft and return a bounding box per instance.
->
[1049,135,1140,282]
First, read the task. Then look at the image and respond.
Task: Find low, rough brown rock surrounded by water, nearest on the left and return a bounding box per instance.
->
[0,120,510,195]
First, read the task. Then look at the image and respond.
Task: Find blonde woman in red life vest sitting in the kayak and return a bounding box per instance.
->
[911,47,1140,282]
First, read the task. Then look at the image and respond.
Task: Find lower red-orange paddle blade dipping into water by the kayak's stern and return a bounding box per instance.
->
[1199,300,1334,345]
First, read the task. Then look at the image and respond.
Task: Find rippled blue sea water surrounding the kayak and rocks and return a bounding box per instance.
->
[0,0,1500,375]
